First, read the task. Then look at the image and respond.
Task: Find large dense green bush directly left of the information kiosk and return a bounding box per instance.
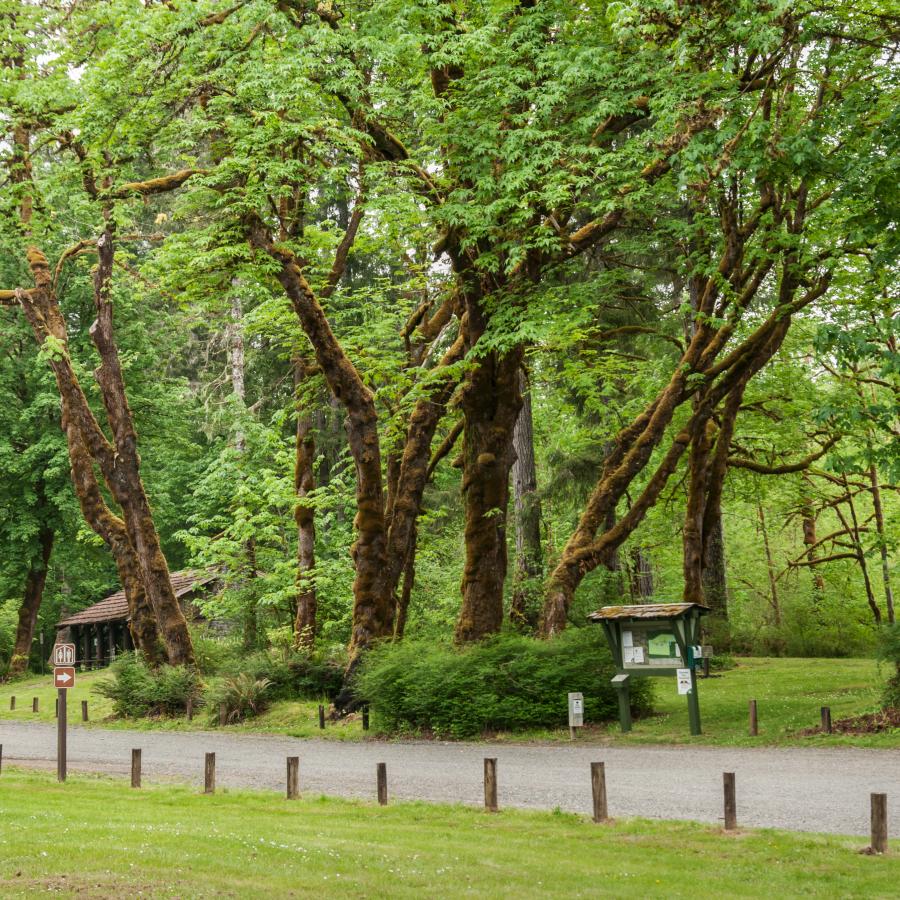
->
[355,628,652,738]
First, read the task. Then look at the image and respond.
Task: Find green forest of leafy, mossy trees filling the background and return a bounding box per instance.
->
[0,0,900,716]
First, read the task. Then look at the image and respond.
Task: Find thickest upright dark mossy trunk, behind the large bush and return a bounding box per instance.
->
[455,350,522,643]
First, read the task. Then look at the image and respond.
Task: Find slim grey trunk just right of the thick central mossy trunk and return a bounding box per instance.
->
[509,370,544,627]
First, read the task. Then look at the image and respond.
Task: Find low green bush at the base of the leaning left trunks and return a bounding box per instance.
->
[94,653,200,718]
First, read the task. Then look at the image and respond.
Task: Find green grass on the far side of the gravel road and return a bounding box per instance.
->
[0,659,900,749]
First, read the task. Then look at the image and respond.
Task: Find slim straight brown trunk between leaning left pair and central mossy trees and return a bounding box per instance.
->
[294,358,317,650]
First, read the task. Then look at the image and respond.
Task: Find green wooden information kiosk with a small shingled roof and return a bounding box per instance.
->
[588,603,709,734]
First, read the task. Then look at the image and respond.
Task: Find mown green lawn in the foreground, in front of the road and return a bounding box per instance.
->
[0,770,900,898]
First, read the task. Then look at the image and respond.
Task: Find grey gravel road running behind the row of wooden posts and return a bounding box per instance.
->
[0,722,900,837]
